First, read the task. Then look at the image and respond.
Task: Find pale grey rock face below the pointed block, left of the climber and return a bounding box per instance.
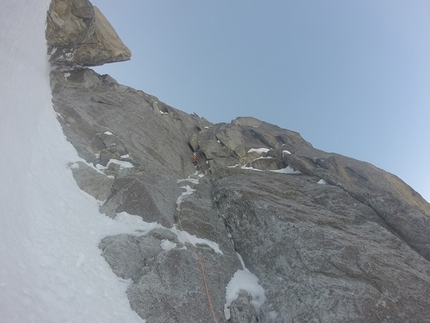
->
[51,69,211,225]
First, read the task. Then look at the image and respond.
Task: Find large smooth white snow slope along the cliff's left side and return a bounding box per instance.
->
[0,0,144,323]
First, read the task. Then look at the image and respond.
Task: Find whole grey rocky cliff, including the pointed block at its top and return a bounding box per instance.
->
[46,0,430,323]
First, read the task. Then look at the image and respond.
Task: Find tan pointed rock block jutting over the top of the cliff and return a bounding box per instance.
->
[45,0,131,68]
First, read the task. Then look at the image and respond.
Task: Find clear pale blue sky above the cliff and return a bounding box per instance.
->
[92,0,430,201]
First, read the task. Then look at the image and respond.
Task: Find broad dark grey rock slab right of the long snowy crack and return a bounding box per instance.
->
[214,169,430,323]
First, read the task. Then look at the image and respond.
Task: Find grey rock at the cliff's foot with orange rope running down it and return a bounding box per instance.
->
[100,179,244,323]
